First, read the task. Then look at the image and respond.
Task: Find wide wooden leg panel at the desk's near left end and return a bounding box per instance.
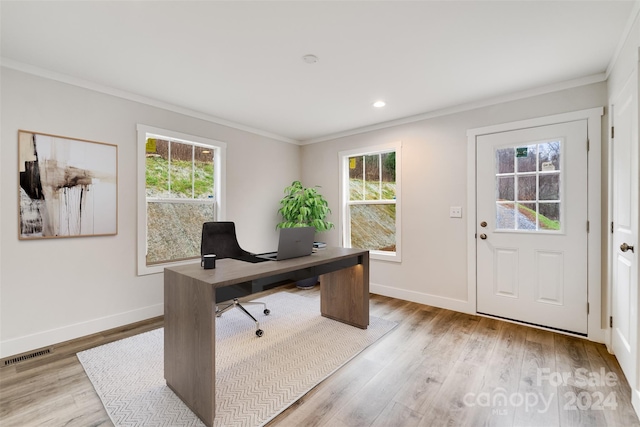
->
[164,270,215,426]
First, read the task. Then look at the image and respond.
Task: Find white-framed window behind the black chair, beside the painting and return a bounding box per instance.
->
[138,125,225,274]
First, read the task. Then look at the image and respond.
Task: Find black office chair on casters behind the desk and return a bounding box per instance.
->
[200,221,270,337]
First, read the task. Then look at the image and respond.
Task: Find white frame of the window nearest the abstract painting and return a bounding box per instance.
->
[136,124,227,276]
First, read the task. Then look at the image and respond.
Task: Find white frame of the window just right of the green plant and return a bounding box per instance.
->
[338,141,402,262]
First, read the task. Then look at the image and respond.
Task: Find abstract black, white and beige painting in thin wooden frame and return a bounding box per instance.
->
[18,130,118,239]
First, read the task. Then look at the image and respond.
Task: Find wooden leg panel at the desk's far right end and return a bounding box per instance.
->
[320,254,369,329]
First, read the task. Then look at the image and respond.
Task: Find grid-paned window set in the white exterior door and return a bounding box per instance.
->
[495,140,563,232]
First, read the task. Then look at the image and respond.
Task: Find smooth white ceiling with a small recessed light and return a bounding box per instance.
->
[0,0,637,143]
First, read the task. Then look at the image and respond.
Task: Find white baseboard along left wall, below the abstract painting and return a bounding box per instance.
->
[0,304,164,359]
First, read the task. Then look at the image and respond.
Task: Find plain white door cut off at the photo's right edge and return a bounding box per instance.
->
[610,73,640,394]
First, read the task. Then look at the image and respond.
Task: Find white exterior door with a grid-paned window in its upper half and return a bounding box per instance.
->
[476,120,588,335]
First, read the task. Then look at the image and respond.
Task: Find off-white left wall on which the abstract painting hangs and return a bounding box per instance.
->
[0,68,300,357]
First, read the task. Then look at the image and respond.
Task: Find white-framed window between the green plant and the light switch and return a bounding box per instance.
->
[339,142,401,261]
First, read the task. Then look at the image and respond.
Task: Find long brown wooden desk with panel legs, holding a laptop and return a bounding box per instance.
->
[164,248,369,426]
